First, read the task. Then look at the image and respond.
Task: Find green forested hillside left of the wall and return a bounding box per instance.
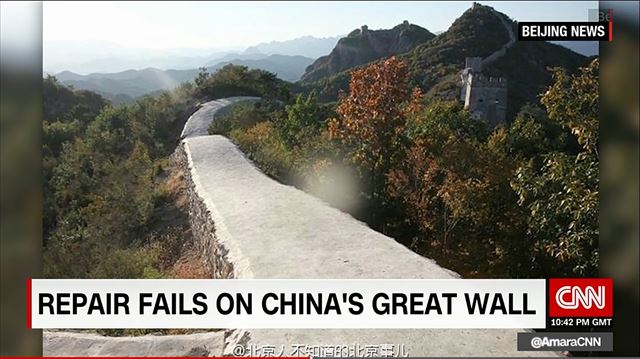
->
[43,65,289,278]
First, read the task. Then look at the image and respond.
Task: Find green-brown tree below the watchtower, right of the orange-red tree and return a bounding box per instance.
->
[387,102,523,276]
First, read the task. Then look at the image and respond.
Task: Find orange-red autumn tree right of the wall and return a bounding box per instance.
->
[329,57,420,214]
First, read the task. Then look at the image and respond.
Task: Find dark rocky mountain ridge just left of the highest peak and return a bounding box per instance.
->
[301,21,435,83]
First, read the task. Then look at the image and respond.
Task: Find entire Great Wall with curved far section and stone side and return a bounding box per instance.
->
[43,97,554,357]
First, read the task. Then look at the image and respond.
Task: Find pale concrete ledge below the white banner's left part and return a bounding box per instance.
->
[42,331,224,356]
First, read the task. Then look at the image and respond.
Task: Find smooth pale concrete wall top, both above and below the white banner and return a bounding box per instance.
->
[183,100,554,356]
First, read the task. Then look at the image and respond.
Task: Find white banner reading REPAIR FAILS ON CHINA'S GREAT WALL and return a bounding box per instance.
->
[28,279,546,329]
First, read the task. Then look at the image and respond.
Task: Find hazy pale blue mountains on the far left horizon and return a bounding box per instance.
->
[50,36,340,104]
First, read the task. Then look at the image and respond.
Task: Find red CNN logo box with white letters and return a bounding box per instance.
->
[549,278,613,318]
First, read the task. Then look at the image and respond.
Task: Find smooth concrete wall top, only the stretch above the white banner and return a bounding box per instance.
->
[183,136,457,278]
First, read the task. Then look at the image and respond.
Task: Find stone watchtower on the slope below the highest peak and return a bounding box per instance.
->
[460,57,507,126]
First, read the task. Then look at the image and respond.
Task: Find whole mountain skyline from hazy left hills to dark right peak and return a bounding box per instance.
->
[51,4,597,109]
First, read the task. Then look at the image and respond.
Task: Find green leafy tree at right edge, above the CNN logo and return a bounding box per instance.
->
[512,59,599,276]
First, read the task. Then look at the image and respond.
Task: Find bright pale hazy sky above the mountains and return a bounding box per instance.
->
[43,1,598,73]
